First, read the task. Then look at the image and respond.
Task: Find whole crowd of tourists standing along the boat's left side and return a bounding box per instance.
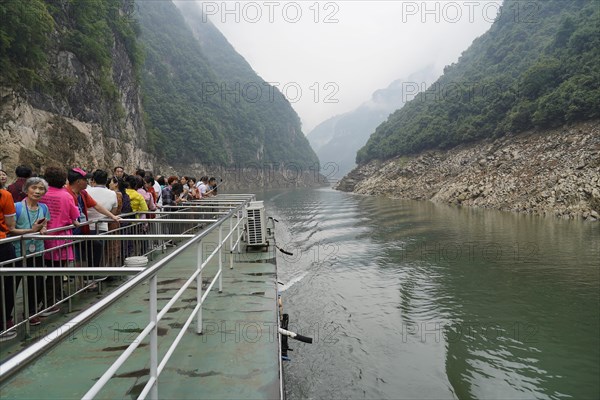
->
[0,165,218,342]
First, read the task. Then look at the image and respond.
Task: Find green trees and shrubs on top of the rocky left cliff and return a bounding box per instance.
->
[0,0,143,100]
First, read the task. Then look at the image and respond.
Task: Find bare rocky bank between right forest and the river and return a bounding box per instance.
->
[337,121,600,221]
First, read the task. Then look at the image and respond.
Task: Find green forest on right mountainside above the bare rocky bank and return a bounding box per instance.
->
[357,0,600,164]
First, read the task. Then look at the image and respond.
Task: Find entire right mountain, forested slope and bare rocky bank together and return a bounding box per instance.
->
[338,0,600,221]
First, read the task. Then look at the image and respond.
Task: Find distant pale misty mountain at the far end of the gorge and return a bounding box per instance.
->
[307,66,436,178]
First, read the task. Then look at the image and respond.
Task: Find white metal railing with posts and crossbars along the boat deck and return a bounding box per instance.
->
[0,195,254,399]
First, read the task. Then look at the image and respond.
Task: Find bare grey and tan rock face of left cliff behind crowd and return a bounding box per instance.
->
[0,20,157,172]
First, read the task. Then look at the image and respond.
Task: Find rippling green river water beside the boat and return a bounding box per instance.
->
[254,189,600,400]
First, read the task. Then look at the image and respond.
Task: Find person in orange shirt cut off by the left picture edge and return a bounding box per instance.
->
[0,178,17,342]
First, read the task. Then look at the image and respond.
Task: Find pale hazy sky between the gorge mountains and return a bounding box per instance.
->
[199,0,501,134]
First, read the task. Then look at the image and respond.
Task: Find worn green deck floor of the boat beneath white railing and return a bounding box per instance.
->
[0,230,280,399]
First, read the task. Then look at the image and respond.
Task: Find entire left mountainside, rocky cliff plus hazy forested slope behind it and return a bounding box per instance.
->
[0,0,318,178]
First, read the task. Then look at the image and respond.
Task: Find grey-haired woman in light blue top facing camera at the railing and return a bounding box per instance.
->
[10,177,51,325]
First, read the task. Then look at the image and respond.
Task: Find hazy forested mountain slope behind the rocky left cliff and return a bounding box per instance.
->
[137,1,318,170]
